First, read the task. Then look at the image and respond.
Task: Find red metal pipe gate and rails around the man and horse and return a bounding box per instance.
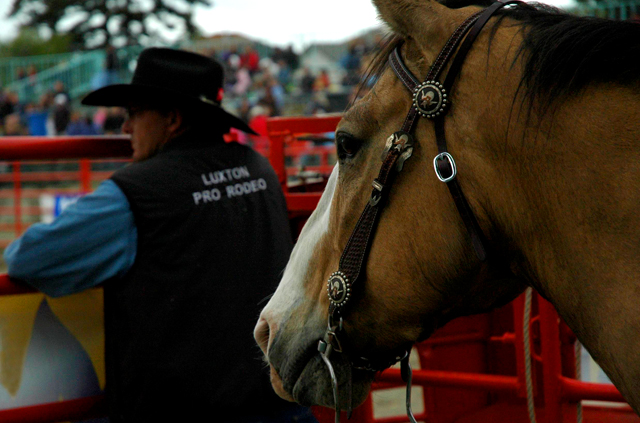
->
[0,116,640,423]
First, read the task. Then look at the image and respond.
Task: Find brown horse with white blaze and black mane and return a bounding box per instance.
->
[255,0,640,412]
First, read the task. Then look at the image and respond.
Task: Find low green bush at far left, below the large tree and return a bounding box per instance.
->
[0,28,71,57]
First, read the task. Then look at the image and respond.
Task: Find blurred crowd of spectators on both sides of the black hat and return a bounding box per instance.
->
[0,36,378,136]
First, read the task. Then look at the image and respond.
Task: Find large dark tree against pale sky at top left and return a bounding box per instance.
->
[9,0,213,48]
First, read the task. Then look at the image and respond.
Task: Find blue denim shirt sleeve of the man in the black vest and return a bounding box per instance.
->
[4,180,138,297]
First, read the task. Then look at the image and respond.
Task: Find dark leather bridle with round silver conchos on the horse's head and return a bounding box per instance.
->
[318,0,520,423]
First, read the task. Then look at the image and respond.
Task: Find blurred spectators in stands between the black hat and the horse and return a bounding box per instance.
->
[208,37,381,141]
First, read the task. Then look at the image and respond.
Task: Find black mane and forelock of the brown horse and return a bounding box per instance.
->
[352,0,640,108]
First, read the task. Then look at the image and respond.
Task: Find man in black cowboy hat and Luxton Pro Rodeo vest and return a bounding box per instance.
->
[5,48,314,422]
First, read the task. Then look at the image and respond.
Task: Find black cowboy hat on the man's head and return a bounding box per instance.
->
[82,47,257,135]
